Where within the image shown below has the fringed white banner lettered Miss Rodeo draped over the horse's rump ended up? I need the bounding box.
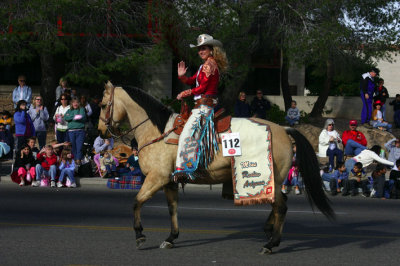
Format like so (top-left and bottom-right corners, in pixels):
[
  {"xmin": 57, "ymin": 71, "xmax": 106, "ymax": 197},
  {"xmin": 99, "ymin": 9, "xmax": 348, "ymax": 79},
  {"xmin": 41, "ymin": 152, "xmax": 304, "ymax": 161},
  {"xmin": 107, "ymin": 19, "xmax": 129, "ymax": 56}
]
[{"xmin": 231, "ymin": 118, "xmax": 275, "ymax": 205}]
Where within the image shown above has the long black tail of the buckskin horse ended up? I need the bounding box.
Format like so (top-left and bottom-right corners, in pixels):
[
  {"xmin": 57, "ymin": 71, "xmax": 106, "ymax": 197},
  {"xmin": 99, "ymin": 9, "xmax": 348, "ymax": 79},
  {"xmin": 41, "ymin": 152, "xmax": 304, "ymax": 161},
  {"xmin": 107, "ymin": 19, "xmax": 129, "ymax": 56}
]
[{"xmin": 286, "ymin": 128, "xmax": 335, "ymax": 221}]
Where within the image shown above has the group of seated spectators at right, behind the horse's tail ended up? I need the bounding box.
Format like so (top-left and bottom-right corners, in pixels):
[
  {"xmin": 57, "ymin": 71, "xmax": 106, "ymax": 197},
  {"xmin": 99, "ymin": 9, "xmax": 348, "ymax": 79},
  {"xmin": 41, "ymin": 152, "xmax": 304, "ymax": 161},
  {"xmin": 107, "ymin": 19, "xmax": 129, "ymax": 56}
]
[{"xmin": 319, "ymin": 119, "xmax": 400, "ymax": 199}]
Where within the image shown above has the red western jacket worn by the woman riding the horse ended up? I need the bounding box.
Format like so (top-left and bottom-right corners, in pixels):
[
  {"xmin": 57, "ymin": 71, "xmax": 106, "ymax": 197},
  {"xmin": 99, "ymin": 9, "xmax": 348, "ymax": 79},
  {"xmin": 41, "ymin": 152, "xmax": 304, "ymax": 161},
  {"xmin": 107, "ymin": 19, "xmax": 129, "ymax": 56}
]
[{"xmin": 179, "ymin": 57, "xmax": 219, "ymax": 95}]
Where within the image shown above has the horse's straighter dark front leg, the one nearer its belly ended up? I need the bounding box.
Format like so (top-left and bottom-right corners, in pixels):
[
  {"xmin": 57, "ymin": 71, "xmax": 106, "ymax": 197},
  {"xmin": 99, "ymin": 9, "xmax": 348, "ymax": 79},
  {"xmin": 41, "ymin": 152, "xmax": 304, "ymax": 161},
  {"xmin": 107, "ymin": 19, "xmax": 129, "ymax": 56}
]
[{"xmin": 160, "ymin": 182, "xmax": 179, "ymax": 248}]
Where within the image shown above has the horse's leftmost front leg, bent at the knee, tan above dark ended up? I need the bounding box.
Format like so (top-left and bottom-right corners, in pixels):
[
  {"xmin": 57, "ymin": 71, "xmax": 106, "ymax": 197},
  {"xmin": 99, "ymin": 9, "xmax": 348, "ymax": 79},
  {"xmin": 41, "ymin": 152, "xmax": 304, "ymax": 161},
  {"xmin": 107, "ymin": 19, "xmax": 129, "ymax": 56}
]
[{"xmin": 133, "ymin": 173, "xmax": 162, "ymax": 248}]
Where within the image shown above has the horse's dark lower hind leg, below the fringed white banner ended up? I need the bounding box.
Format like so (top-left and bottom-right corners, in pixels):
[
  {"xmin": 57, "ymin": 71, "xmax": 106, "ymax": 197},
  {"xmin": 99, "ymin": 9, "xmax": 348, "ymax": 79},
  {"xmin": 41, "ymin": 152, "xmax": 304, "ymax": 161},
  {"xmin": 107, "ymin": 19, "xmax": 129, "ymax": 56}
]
[{"xmin": 260, "ymin": 185, "xmax": 287, "ymax": 254}]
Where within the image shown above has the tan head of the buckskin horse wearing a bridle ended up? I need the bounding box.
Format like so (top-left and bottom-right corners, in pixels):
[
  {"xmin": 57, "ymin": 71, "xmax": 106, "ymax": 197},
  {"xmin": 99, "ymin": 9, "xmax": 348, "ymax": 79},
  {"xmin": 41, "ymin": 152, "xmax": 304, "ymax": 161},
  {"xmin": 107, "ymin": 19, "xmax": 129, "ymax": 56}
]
[{"xmin": 97, "ymin": 81, "xmax": 126, "ymax": 138}]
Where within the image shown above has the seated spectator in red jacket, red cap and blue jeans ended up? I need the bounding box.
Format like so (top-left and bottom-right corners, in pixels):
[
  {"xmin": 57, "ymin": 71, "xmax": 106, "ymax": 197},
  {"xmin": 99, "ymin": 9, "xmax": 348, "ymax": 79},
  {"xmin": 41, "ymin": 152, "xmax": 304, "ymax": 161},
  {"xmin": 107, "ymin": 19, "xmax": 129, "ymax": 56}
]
[{"xmin": 342, "ymin": 120, "xmax": 367, "ymax": 155}]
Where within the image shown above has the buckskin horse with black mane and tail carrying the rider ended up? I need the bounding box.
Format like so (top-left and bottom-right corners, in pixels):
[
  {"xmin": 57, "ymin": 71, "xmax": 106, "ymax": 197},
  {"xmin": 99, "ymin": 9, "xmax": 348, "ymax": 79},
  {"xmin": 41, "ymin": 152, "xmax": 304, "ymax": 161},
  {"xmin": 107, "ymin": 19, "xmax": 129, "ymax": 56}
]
[{"xmin": 98, "ymin": 82, "xmax": 335, "ymax": 254}]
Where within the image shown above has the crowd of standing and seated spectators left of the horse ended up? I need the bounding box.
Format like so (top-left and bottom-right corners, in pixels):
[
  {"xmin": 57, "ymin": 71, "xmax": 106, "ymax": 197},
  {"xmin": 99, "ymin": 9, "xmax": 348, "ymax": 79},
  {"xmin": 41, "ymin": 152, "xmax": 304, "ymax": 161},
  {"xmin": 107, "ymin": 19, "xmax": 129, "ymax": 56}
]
[{"xmin": 0, "ymin": 75, "xmax": 141, "ymax": 187}]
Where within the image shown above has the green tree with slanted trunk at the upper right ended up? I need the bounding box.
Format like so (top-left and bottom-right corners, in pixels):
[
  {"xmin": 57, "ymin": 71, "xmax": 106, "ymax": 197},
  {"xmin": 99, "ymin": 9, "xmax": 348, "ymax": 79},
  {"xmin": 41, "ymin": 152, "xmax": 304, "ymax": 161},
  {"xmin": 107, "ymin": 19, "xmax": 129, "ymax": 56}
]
[{"xmin": 272, "ymin": 0, "xmax": 400, "ymax": 116}]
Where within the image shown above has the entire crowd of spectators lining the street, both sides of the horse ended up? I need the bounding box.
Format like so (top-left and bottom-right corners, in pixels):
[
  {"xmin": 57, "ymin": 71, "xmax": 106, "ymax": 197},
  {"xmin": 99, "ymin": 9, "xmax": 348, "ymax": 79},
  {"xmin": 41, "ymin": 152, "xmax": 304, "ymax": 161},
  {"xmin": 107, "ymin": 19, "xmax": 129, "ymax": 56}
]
[{"xmin": 0, "ymin": 72, "xmax": 400, "ymax": 198}]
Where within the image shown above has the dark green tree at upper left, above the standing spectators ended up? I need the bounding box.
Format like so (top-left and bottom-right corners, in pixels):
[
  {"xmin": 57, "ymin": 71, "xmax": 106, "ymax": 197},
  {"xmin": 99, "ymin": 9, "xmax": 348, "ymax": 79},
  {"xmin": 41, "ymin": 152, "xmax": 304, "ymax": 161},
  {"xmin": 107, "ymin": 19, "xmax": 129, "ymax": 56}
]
[{"xmin": 0, "ymin": 0, "xmax": 160, "ymax": 105}]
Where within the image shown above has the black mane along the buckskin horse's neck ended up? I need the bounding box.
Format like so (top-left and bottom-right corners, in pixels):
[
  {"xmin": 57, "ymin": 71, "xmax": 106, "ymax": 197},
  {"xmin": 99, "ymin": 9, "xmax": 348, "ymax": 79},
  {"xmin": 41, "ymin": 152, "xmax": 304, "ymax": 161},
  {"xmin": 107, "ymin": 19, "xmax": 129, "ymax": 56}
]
[{"xmin": 121, "ymin": 86, "xmax": 173, "ymax": 133}]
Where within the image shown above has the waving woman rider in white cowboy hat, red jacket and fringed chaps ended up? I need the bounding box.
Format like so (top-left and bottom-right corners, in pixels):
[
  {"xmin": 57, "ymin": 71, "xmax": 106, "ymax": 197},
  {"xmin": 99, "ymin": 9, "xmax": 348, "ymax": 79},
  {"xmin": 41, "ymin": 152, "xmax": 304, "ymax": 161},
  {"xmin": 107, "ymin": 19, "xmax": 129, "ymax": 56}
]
[{"xmin": 173, "ymin": 34, "xmax": 228, "ymax": 181}]
